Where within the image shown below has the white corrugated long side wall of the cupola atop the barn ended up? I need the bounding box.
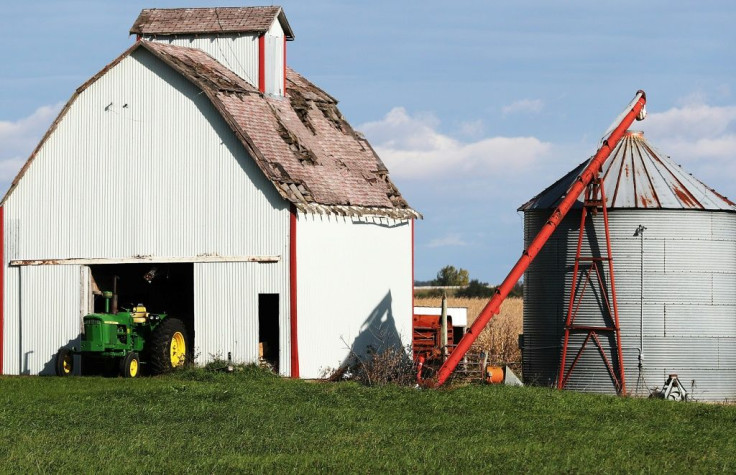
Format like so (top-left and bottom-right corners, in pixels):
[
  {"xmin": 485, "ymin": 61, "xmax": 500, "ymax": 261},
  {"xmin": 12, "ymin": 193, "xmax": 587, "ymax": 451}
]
[{"xmin": 151, "ymin": 34, "xmax": 260, "ymax": 88}]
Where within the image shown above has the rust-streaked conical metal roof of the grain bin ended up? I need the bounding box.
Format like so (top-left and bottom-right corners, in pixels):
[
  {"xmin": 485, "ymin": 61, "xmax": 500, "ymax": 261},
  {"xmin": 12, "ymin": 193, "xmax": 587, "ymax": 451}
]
[{"xmin": 519, "ymin": 131, "xmax": 736, "ymax": 211}]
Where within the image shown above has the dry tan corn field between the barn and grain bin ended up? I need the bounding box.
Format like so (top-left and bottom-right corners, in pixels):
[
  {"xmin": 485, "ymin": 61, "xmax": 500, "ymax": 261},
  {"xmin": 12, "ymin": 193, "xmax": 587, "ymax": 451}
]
[{"xmin": 414, "ymin": 297, "xmax": 523, "ymax": 369}]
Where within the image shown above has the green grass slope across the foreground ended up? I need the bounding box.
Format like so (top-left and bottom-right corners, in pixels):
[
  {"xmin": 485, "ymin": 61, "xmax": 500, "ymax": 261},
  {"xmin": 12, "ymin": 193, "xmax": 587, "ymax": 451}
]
[{"xmin": 0, "ymin": 369, "xmax": 736, "ymax": 473}]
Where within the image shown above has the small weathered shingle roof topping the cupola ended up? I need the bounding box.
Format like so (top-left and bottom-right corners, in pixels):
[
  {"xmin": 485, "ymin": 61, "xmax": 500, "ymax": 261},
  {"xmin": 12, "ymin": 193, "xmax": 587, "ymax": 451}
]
[{"xmin": 130, "ymin": 6, "xmax": 294, "ymax": 40}]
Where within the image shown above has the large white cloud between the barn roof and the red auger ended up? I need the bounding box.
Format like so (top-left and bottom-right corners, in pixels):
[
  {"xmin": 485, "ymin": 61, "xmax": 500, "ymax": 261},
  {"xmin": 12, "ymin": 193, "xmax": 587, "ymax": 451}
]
[{"xmin": 360, "ymin": 107, "xmax": 550, "ymax": 178}]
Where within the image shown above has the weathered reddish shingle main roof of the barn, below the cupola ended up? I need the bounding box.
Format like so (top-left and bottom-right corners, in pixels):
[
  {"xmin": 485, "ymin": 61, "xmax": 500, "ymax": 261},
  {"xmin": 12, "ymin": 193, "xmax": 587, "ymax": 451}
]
[{"xmin": 3, "ymin": 41, "xmax": 421, "ymax": 218}]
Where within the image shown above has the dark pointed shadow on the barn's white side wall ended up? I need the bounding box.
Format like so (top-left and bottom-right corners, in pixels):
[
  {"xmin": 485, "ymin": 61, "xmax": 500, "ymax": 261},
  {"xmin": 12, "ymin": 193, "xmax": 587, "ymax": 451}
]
[{"xmin": 340, "ymin": 290, "xmax": 406, "ymax": 368}]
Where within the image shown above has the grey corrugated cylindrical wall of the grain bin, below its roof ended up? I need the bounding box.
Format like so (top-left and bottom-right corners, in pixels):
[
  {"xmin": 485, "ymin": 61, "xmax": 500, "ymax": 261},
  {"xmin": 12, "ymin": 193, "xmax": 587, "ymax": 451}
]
[{"xmin": 524, "ymin": 209, "xmax": 736, "ymax": 400}]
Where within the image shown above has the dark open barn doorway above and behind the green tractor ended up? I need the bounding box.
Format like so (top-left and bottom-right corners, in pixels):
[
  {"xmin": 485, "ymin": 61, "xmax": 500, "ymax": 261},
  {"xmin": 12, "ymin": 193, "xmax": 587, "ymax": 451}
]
[{"xmin": 89, "ymin": 263, "xmax": 195, "ymax": 348}]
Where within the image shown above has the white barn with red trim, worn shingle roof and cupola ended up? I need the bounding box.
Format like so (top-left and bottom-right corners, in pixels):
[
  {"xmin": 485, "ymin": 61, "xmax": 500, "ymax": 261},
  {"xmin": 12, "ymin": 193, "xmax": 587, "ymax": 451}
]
[{"xmin": 0, "ymin": 7, "xmax": 420, "ymax": 378}]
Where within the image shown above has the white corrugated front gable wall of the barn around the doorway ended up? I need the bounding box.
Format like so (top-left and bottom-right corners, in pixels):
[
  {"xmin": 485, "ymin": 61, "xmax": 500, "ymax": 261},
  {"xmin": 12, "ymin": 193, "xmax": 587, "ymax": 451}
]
[{"xmin": 4, "ymin": 49, "xmax": 289, "ymax": 374}]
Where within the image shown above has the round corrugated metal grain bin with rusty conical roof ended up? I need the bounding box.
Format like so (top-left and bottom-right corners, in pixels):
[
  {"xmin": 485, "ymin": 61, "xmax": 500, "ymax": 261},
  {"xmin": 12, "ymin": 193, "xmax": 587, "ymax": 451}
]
[{"xmin": 520, "ymin": 131, "xmax": 736, "ymax": 400}]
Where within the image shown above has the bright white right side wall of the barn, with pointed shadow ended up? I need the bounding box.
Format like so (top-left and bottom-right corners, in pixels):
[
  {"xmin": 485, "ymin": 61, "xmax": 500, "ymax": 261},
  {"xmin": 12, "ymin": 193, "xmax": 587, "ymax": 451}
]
[{"xmin": 296, "ymin": 213, "xmax": 413, "ymax": 378}]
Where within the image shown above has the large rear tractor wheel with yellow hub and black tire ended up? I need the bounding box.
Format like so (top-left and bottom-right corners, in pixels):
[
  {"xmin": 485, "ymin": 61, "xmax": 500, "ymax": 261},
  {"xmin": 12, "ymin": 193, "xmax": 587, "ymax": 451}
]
[{"xmin": 149, "ymin": 318, "xmax": 189, "ymax": 374}]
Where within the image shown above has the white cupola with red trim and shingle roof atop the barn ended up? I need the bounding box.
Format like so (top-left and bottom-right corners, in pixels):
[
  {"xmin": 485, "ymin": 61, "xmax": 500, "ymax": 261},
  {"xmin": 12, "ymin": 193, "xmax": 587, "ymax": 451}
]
[{"xmin": 130, "ymin": 6, "xmax": 294, "ymax": 96}]
